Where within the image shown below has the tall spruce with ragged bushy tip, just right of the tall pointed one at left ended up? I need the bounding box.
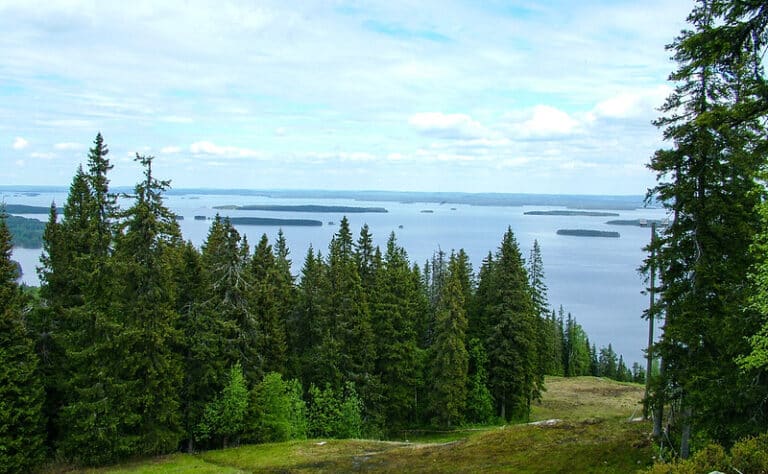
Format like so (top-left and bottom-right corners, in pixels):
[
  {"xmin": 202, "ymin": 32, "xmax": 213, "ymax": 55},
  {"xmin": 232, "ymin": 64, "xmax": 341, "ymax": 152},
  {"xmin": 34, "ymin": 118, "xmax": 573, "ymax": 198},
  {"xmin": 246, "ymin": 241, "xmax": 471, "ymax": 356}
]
[{"xmin": 112, "ymin": 154, "xmax": 182, "ymax": 455}]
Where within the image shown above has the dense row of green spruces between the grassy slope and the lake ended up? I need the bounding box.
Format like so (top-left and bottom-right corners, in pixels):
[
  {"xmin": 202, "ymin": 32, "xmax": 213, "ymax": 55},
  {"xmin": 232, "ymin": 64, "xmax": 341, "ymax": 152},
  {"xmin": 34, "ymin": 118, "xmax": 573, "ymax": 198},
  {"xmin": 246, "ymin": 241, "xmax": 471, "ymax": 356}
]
[{"xmin": 0, "ymin": 135, "xmax": 643, "ymax": 472}]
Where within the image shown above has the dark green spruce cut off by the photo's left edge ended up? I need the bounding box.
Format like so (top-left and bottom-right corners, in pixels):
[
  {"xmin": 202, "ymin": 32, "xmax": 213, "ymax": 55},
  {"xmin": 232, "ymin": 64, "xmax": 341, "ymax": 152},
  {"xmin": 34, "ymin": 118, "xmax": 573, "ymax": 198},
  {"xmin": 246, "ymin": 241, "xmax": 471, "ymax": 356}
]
[{"xmin": 0, "ymin": 206, "xmax": 45, "ymax": 472}]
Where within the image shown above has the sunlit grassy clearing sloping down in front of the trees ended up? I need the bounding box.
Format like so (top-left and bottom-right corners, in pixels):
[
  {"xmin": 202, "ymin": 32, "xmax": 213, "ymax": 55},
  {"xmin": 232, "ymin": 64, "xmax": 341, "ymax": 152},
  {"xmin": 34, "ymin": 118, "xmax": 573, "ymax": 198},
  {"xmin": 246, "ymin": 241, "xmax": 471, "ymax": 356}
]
[{"xmin": 66, "ymin": 377, "xmax": 652, "ymax": 474}]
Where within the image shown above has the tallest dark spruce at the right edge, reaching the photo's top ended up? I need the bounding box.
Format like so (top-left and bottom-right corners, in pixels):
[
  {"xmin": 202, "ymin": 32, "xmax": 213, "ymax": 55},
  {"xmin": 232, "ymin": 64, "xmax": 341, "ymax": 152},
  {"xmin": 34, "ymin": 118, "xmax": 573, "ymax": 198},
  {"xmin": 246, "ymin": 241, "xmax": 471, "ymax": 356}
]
[{"xmin": 649, "ymin": 0, "xmax": 766, "ymax": 450}]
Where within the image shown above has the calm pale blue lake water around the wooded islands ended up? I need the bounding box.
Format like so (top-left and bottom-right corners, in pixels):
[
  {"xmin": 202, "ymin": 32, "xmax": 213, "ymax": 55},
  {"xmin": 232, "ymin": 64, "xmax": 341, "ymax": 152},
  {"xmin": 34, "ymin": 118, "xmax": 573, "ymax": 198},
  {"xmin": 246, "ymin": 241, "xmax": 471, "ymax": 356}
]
[{"xmin": 4, "ymin": 193, "xmax": 664, "ymax": 366}]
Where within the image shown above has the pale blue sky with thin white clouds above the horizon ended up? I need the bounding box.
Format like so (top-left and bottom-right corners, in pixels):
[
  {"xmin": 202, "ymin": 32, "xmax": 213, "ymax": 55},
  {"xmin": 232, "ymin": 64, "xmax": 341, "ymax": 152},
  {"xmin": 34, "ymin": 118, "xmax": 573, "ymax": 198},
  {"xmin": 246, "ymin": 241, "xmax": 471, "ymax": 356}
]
[{"xmin": 0, "ymin": 0, "xmax": 693, "ymax": 194}]
